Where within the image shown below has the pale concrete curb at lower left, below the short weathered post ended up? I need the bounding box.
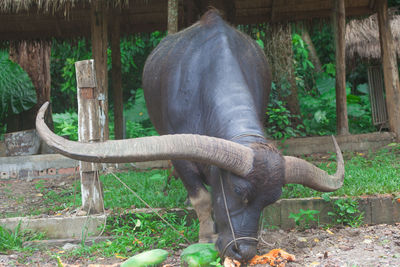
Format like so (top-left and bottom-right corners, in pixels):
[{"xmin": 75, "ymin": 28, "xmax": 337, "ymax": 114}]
[{"xmin": 0, "ymin": 215, "xmax": 106, "ymax": 239}]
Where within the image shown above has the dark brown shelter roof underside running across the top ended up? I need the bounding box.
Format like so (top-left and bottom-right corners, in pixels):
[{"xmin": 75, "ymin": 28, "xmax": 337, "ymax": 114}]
[{"xmin": 0, "ymin": 0, "xmax": 380, "ymax": 41}]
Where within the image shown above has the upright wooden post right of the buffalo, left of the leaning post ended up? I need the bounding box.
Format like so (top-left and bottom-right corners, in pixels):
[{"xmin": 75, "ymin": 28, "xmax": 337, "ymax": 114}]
[{"xmin": 333, "ymin": 0, "xmax": 349, "ymax": 135}]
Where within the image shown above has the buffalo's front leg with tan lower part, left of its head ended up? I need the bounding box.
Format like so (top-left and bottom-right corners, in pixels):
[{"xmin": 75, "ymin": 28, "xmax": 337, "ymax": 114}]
[{"xmin": 172, "ymin": 160, "xmax": 217, "ymax": 243}]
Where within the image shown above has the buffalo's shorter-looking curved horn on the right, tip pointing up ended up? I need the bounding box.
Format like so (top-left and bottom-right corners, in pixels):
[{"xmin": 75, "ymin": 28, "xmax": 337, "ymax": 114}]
[{"xmin": 284, "ymin": 136, "xmax": 344, "ymax": 192}]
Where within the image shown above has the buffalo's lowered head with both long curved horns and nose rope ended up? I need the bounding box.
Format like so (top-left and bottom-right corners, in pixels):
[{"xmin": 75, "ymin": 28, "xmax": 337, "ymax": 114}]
[{"xmin": 36, "ymin": 103, "xmax": 344, "ymax": 261}]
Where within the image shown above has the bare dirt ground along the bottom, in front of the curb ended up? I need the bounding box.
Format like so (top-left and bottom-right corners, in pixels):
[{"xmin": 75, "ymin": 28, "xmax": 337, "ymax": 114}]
[{"xmin": 0, "ymin": 224, "xmax": 400, "ymax": 267}]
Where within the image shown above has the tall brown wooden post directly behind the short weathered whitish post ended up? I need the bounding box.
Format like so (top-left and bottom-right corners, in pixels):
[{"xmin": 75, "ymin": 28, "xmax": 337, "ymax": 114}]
[{"xmin": 91, "ymin": 0, "xmax": 109, "ymax": 141}]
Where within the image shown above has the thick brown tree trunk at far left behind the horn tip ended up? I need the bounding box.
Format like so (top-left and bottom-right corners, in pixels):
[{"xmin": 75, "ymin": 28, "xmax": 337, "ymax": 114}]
[{"xmin": 7, "ymin": 41, "xmax": 53, "ymax": 132}]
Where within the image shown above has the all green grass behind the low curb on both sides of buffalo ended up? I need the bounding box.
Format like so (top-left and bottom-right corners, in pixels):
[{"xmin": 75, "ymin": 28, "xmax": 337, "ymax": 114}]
[{"xmin": 36, "ymin": 145, "xmax": 400, "ymax": 213}]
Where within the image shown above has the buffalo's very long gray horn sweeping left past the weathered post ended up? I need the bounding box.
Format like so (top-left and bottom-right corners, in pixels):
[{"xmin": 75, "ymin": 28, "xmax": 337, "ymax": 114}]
[{"xmin": 36, "ymin": 102, "xmax": 254, "ymax": 177}]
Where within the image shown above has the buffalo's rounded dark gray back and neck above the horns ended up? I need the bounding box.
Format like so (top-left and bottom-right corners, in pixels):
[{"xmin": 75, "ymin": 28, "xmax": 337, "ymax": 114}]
[{"xmin": 143, "ymin": 12, "xmax": 270, "ymax": 142}]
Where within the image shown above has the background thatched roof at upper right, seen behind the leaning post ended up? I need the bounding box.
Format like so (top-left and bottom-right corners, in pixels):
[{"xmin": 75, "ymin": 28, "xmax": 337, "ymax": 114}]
[{"xmin": 346, "ymin": 9, "xmax": 400, "ymax": 59}]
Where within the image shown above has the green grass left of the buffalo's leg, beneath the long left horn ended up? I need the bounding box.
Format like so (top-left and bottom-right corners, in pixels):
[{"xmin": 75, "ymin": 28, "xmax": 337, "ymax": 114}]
[{"xmin": 42, "ymin": 170, "xmax": 187, "ymax": 214}]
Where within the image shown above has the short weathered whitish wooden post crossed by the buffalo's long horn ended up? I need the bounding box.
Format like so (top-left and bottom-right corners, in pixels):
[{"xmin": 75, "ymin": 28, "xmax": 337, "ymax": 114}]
[{"xmin": 75, "ymin": 60, "xmax": 104, "ymax": 214}]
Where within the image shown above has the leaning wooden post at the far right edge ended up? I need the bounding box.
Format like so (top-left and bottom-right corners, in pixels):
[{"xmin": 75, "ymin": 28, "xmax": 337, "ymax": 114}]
[{"xmin": 376, "ymin": 0, "xmax": 400, "ymax": 141}]
